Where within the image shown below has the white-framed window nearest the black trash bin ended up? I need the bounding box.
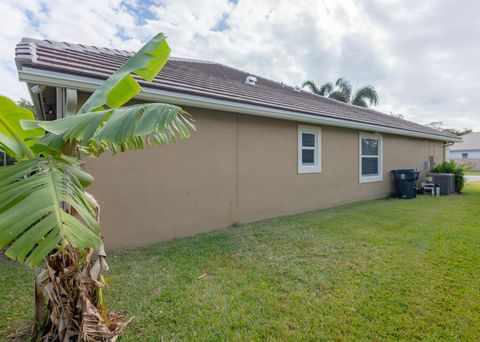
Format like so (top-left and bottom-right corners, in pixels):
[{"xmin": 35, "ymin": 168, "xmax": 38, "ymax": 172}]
[{"xmin": 359, "ymin": 133, "xmax": 383, "ymax": 183}]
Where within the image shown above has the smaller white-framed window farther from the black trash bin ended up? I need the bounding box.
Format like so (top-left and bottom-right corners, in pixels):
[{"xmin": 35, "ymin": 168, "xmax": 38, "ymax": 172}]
[{"xmin": 298, "ymin": 126, "xmax": 322, "ymax": 173}]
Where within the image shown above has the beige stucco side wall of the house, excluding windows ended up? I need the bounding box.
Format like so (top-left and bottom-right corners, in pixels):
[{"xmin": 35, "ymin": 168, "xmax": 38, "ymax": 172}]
[{"xmin": 83, "ymin": 104, "xmax": 443, "ymax": 249}]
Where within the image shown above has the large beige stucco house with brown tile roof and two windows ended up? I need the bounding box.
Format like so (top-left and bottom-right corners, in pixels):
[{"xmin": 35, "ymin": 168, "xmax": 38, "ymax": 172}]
[{"xmin": 16, "ymin": 39, "xmax": 459, "ymax": 248}]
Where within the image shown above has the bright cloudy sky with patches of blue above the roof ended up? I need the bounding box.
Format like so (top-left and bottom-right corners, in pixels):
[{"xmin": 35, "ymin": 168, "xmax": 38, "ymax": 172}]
[{"xmin": 0, "ymin": 0, "xmax": 480, "ymax": 131}]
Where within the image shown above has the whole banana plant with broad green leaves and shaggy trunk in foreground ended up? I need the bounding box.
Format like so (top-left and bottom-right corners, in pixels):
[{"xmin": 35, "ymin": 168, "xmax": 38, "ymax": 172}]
[{"xmin": 0, "ymin": 33, "xmax": 194, "ymax": 341}]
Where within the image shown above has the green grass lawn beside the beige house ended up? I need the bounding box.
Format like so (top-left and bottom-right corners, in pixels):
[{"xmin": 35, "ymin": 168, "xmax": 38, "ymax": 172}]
[{"xmin": 0, "ymin": 184, "xmax": 480, "ymax": 341}]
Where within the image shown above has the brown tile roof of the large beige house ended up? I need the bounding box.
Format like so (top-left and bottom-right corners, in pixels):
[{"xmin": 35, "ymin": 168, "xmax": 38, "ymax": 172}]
[{"xmin": 15, "ymin": 38, "xmax": 455, "ymax": 139}]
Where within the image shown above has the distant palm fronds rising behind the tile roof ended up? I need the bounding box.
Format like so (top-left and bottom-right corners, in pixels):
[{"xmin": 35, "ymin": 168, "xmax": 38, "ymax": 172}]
[{"xmin": 303, "ymin": 77, "xmax": 378, "ymax": 108}]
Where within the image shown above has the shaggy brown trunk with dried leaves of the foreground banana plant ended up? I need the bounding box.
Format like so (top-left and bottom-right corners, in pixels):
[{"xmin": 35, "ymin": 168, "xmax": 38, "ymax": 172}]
[{"xmin": 33, "ymin": 188, "xmax": 130, "ymax": 342}]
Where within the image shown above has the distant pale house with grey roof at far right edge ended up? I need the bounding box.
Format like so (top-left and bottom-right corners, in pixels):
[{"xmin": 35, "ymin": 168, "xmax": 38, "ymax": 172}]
[{"xmin": 448, "ymin": 132, "xmax": 480, "ymax": 171}]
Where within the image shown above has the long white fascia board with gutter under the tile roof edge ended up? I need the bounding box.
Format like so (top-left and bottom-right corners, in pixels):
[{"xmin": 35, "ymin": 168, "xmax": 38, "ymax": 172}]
[{"xmin": 18, "ymin": 67, "xmax": 461, "ymax": 142}]
